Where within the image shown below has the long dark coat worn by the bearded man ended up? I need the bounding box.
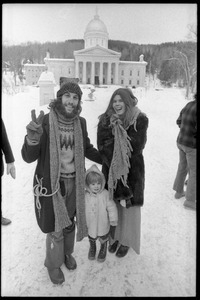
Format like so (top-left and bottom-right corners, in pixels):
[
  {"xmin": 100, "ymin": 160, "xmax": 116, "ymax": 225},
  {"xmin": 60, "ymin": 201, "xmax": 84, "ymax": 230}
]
[{"xmin": 21, "ymin": 114, "xmax": 102, "ymax": 233}]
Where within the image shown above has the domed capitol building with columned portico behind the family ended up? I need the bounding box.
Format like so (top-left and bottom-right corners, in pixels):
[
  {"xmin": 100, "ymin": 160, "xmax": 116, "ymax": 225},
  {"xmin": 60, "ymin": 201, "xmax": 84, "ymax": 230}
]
[{"xmin": 24, "ymin": 12, "xmax": 147, "ymax": 87}]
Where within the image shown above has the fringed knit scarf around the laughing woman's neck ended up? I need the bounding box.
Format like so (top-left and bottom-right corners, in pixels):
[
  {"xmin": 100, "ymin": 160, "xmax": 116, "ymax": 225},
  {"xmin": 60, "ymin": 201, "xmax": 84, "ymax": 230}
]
[{"xmin": 108, "ymin": 107, "xmax": 140, "ymax": 199}]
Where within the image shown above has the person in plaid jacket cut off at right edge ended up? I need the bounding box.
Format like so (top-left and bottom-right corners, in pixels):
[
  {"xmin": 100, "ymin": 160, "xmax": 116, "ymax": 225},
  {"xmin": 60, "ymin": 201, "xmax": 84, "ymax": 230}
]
[{"xmin": 173, "ymin": 94, "xmax": 197, "ymax": 210}]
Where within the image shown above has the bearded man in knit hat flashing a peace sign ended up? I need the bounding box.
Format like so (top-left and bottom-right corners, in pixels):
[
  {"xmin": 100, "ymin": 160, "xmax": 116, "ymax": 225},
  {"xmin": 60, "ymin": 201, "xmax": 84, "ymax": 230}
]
[{"xmin": 22, "ymin": 82, "xmax": 102, "ymax": 284}]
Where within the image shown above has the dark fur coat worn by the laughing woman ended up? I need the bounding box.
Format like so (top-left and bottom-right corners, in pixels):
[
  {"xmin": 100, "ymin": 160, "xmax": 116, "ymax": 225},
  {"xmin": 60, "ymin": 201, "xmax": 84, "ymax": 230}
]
[{"xmin": 97, "ymin": 112, "xmax": 149, "ymax": 206}]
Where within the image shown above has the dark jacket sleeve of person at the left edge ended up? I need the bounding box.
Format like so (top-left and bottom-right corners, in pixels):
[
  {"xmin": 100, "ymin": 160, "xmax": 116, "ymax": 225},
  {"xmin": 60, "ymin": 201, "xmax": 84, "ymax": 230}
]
[{"xmin": 1, "ymin": 119, "xmax": 15, "ymax": 176}]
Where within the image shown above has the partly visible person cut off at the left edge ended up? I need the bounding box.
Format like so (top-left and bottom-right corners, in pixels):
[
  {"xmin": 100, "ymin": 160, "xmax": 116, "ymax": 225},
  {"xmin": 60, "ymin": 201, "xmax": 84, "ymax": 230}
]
[{"xmin": 1, "ymin": 119, "xmax": 16, "ymax": 225}]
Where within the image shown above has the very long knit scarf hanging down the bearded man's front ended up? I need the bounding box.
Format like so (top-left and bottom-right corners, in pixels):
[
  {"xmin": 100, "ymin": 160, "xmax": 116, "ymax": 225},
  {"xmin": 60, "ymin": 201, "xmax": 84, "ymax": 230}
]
[{"xmin": 49, "ymin": 109, "xmax": 87, "ymax": 241}]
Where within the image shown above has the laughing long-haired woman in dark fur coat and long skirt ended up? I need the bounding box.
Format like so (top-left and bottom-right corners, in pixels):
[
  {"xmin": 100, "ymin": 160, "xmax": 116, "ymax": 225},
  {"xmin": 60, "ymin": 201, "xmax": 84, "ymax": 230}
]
[{"xmin": 97, "ymin": 88, "xmax": 148, "ymax": 257}]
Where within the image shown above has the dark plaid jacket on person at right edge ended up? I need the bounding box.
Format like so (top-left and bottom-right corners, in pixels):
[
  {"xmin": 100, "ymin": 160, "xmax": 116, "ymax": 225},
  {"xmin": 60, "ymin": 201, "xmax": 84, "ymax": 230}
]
[{"xmin": 176, "ymin": 100, "xmax": 197, "ymax": 148}]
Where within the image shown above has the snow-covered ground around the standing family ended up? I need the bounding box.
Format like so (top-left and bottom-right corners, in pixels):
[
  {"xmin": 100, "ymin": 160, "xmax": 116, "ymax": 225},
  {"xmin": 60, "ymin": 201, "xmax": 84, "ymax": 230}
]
[{"xmin": 1, "ymin": 85, "xmax": 196, "ymax": 297}]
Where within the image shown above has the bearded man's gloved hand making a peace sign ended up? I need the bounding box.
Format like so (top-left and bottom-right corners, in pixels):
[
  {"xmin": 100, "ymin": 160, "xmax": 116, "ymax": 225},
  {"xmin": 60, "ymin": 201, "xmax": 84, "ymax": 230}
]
[{"xmin": 26, "ymin": 109, "xmax": 44, "ymax": 143}]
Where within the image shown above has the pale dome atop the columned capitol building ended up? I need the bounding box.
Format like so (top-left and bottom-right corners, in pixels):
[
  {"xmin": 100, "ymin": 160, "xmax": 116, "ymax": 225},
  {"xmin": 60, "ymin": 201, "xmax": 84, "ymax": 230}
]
[{"xmin": 84, "ymin": 13, "xmax": 108, "ymax": 48}]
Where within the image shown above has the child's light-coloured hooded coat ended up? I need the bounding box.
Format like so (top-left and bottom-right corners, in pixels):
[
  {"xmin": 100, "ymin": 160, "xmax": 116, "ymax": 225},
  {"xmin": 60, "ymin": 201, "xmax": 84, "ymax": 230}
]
[{"xmin": 85, "ymin": 165, "xmax": 118, "ymax": 238}]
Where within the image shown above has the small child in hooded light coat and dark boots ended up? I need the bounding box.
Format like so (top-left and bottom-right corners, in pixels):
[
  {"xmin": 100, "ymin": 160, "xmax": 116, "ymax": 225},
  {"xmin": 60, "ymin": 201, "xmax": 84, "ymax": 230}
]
[{"xmin": 85, "ymin": 165, "xmax": 118, "ymax": 262}]
